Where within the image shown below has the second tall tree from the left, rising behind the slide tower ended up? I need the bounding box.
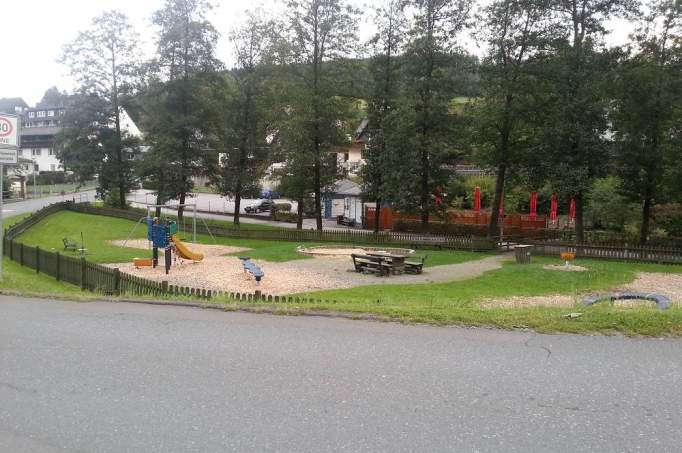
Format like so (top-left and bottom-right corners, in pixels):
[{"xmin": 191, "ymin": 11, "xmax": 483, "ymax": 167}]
[{"xmin": 141, "ymin": 0, "xmax": 220, "ymax": 219}]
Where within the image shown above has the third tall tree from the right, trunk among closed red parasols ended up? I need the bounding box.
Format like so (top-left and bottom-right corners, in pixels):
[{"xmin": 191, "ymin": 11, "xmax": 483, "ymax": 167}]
[{"xmin": 474, "ymin": 0, "xmax": 555, "ymax": 237}]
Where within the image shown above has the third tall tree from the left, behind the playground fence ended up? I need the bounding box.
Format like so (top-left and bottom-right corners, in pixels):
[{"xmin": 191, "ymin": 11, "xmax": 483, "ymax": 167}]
[{"xmin": 211, "ymin": 13, "xmax": 274, "ymax": 225}]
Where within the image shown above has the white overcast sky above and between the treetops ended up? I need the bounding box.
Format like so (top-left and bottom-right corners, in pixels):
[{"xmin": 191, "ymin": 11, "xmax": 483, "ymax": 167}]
[{"xmin": 0, "ymin": 0, "xmax": 631, "ymax": 105}]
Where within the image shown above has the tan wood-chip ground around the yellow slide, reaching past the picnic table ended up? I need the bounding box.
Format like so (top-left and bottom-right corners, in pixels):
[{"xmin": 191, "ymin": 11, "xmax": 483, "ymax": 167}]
[{"xmin": 103, "ymin": 240, "xmax": 504, "ymax": 295}]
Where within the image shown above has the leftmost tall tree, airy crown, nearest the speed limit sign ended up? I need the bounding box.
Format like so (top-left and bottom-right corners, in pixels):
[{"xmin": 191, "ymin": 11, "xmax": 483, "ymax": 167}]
[{"xmin": 61, "ymin": 11, "xmax": 138, "ymax": 208}]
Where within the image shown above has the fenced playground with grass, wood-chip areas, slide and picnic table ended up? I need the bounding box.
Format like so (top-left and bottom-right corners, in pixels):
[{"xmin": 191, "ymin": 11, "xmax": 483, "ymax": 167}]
[{"xmin": 6, "ymin": 206, "xmax": 682, "ymax": 334}]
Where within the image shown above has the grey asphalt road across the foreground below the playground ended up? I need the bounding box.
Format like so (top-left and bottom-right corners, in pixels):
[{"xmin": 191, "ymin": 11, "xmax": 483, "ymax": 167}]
[{"xmin": 0, "ymin": 297, "xmax": 682, "ymax": 452}]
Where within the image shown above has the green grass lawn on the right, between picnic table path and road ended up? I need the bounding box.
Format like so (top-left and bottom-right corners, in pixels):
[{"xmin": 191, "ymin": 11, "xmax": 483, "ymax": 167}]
[{"xmin": 290, "ymin": 257, "xmax": 682, "ymax": 335}]
